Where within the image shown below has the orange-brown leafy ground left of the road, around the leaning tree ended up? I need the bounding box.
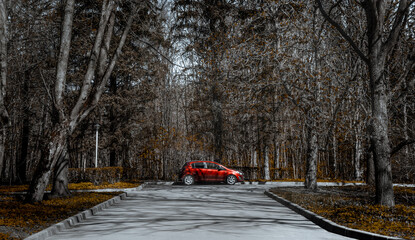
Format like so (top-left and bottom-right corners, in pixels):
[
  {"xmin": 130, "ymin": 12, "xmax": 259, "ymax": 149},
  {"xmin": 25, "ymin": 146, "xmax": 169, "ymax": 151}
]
[{"xmin": 0, "ymin": 182, "xmax": 140, "ymax": 239}]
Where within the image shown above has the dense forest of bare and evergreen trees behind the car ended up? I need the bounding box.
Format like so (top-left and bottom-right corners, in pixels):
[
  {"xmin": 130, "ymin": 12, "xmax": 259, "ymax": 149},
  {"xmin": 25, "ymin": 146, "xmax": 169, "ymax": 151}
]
[{"xmin": 0, "ymin": 0, "xmax": 415, "ymax": 206}]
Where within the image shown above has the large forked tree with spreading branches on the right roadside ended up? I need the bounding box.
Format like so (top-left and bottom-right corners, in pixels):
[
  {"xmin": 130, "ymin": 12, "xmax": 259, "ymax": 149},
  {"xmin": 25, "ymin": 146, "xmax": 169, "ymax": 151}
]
[{"xmin": 316, "ymin": 0, "xmax": 414, "ymax": 206}]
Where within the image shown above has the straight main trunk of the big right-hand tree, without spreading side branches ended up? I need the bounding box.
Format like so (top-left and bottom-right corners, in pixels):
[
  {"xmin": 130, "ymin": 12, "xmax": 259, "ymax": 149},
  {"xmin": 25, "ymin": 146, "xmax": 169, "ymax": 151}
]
[{"xmin": 365, "ymin": 1, "xmax": 396, "ymax": 207}]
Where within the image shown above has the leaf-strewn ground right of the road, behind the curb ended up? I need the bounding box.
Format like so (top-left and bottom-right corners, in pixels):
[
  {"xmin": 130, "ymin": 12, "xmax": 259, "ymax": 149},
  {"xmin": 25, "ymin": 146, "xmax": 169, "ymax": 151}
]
[{"xmin": 270, "ymin": 186, "xmax": 415, "ymax": 239}]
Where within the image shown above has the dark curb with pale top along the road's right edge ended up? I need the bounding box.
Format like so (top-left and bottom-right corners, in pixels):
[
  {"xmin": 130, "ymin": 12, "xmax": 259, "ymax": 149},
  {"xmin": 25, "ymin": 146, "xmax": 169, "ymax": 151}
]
[{"xmin": 264, "ymin": 191, "xmax": 402, "ymax": 240}]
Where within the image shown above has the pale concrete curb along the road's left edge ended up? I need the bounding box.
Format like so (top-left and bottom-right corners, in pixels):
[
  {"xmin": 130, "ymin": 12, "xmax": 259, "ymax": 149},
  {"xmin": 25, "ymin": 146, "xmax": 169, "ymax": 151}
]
[{"xmin": 25, "ymin": 183, "xmax": 147, "ymax": 240}]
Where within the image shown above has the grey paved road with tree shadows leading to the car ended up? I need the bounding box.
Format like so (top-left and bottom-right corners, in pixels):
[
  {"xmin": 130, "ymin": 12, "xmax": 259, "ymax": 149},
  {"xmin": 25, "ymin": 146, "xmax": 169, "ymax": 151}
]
[{"xmin": 48, "ymin": 184, "xmax": 349, "ymax": 240}]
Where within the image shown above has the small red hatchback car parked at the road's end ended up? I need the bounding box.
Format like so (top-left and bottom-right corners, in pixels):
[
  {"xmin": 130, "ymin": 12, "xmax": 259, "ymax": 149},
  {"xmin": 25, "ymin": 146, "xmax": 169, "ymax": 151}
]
[{"xmin": 179, "ymin": 161, "xmax": 244, "ymax": 185}]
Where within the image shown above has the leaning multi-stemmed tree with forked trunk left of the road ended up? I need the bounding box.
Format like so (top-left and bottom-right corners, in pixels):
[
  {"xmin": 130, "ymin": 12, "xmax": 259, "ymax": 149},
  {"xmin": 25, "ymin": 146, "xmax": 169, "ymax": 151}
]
[{"xmin": 26, "ymin": 0, "xmax": 136, "ymax": 202}]
